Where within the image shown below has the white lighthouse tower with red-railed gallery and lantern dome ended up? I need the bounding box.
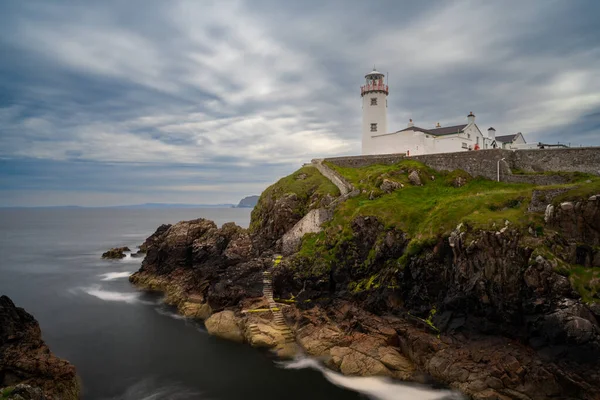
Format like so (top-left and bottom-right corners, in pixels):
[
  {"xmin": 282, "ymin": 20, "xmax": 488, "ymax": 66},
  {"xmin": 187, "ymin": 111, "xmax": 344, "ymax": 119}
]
[{"xmin": 360, "ymin": 68, "xmax": 389, "ymax": 154}]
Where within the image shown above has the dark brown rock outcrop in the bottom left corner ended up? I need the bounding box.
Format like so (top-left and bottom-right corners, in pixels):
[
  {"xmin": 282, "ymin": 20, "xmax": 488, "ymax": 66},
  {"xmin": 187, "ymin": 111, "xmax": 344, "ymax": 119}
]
[{"xmin": 0, "ymin": 296, "xmax": 79, "ymax": 400}]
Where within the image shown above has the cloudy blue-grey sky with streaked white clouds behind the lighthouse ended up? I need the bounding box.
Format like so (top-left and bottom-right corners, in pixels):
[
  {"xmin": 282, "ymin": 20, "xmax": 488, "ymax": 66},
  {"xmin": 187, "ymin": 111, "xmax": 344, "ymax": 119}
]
[{"xmin": 0, "ymin": 0, "xmax": 600, "ymax": 206}]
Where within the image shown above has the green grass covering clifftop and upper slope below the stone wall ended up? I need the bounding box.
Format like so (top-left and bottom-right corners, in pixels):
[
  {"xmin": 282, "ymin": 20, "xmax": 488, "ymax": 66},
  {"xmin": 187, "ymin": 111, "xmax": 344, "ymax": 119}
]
[{"xmin": 276, "ymin": 160, "xmax": 600, "ymax": 300}]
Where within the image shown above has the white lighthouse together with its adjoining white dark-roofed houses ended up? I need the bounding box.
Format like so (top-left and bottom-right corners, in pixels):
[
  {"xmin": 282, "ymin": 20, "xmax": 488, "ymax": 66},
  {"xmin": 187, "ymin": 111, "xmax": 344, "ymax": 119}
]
[{"xmin": 361, "ymin": 70, "xmax": 525, "ymax": 155}]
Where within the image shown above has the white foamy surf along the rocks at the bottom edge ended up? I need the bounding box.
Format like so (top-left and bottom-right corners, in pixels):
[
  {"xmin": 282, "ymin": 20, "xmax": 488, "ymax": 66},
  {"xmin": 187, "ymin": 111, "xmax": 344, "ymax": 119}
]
[{"xmin": 277, "ymin": 357, "xmax": 464, "ymax": 400}]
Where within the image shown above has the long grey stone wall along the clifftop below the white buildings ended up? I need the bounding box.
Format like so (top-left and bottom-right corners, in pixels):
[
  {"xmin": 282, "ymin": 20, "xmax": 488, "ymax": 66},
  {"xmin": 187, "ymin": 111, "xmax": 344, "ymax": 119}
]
[{"xmin": 324, "ymin": 147, "xmax": 600, "ymax": 183}]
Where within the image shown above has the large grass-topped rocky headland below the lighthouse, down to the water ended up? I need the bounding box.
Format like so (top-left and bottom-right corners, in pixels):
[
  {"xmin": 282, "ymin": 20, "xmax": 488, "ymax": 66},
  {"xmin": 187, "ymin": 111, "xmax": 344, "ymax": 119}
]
[{"xmin": 131, "ymin": 161, "xmax": 600, "ymax": 399}]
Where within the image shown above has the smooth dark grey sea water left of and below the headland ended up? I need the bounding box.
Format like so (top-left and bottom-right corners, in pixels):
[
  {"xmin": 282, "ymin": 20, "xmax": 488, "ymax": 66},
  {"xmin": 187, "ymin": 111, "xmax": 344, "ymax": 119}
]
[{"xmin": 0, "ymin": 208, "xmax": 455, "ymax": 400}]
